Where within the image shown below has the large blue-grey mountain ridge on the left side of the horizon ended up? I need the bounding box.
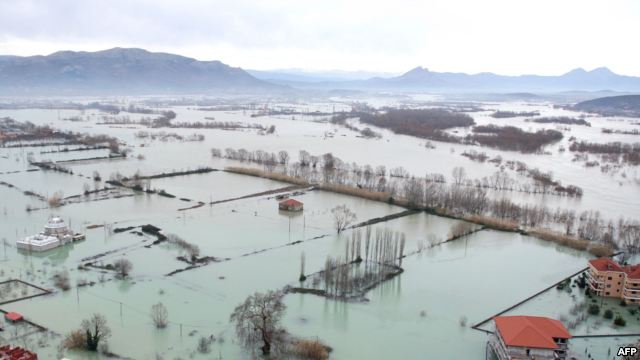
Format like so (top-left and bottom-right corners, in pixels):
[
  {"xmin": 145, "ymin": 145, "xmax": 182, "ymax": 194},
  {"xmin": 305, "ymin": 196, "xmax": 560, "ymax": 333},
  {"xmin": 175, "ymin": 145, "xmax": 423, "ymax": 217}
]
[{"xmin": 0, "ymin": 48, "xmax": 281, "ymax": 95}]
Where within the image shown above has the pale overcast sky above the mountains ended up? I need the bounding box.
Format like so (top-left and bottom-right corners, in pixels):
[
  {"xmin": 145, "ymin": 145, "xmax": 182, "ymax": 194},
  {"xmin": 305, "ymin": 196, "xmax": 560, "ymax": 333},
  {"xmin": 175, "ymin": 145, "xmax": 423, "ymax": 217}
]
[{"xmin": 0, "ymin": 0, "xmax": 640, "ymax": 76}]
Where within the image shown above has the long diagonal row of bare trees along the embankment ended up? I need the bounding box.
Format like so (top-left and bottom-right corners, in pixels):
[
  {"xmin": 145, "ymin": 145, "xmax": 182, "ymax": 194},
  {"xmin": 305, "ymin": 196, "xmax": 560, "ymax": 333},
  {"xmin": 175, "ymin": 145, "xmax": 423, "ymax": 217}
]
[{"xmin": 219, "ymin": 146, "xmax": 640, "ymax": 251}]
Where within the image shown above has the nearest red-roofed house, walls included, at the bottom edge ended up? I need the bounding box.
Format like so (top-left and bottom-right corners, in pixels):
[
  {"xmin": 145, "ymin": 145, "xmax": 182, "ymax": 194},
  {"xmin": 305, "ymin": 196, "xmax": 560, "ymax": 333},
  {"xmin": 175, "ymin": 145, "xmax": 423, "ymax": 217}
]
[{"xmin": 489, "ymin": 316, "xmax": 571, "ymax": 360}]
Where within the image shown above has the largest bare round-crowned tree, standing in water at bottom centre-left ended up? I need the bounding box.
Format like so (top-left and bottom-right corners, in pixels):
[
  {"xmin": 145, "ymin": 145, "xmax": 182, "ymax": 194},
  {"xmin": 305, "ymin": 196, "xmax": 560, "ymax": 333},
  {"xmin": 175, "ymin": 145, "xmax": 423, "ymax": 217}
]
[{"xmin": 230, "ymin": 291, "xmax": 286, "ymax": 355}]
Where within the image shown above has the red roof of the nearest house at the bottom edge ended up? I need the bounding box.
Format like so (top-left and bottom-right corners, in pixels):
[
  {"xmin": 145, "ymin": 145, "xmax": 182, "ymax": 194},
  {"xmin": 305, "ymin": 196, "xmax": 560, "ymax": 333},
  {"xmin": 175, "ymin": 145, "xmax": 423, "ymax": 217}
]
[{"xmin": 493, "ymin": 316, "xmax": 571, "ymax": 349}]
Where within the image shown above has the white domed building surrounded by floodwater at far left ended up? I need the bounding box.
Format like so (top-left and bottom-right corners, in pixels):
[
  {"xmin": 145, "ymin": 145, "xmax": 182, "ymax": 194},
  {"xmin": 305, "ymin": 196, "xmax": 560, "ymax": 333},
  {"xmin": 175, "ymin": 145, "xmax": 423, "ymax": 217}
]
[{"xmin": 16, "ymin": 217, "xmax": 84, "ymax": 252}]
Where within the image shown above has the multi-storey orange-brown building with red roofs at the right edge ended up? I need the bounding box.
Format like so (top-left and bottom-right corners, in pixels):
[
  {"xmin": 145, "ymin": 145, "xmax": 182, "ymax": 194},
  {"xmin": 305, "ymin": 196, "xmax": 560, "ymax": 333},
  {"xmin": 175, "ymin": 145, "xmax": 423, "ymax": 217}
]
[{"xmin": 587, "ymin": 258, "xmax": 640, "ymax": 304}]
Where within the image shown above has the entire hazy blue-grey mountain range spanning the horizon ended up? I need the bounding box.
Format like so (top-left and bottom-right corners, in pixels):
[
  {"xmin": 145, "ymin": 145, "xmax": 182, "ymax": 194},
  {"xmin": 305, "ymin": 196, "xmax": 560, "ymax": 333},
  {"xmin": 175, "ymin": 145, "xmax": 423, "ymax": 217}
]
[{"xmin": 0, "ymin": 48, "xmax": 640, "ymax": 95}]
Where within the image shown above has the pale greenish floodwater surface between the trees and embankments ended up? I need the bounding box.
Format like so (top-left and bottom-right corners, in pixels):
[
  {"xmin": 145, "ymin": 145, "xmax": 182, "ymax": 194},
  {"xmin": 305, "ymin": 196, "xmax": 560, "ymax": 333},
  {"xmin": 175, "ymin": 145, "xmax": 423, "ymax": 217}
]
[{"xmin": 0, "ymin": 96, "xmax": 640, "ymax": 360}]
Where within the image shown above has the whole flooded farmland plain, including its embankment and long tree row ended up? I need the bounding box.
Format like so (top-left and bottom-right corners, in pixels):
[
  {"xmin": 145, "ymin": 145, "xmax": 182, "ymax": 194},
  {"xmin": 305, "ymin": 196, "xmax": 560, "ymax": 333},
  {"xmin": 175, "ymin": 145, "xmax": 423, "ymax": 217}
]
[{"xmin": 0, "ymin": 97, "xmax": 640, "ymax": 360}]
